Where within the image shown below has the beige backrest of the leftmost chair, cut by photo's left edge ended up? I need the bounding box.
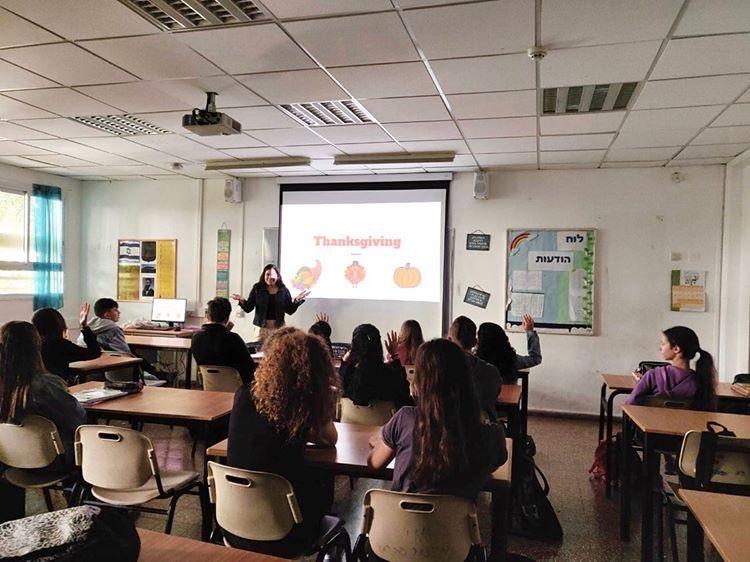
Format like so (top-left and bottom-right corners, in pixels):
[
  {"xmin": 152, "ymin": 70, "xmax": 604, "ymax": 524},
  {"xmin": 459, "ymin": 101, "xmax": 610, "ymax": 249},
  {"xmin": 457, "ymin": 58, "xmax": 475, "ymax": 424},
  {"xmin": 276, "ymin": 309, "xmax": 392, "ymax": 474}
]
[{"xmin": 0, "ymin": 415, "xmax": 65, "ymax": 469}]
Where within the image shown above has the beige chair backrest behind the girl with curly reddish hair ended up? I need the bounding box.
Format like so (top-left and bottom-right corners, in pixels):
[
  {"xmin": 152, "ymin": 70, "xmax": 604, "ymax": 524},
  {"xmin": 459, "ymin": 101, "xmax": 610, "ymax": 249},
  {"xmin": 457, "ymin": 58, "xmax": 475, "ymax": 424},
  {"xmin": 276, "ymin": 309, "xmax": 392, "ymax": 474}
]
[{"xmin": 208, "ymin": 461, "xmax": 302, "ymax": 541}]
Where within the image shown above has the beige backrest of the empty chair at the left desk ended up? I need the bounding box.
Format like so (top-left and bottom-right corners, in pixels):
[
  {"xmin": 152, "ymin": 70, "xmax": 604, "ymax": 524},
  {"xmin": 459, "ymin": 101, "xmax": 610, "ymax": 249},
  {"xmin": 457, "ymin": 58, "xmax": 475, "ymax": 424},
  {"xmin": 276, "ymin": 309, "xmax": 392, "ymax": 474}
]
[{"xmin": 75, "ymin": 425, "xmax": 161, "ymax": 491}]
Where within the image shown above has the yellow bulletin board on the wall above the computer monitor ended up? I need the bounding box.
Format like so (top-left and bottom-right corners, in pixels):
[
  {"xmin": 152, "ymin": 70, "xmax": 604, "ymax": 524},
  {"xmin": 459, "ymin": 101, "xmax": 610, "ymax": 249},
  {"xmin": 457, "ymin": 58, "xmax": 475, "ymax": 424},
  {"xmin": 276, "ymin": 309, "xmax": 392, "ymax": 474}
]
[{"xmin": 117, "ymin": 239, "xmax": 177, "ymax": 301}]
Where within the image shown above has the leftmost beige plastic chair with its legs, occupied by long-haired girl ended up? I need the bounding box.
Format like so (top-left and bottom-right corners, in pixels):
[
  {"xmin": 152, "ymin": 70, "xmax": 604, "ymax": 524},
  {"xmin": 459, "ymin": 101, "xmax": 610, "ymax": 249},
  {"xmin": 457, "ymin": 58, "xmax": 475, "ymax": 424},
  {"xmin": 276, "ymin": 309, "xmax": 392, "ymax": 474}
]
[{"xmin": 0, "ymin": 415, "xmax": 78, "ymax": 511}]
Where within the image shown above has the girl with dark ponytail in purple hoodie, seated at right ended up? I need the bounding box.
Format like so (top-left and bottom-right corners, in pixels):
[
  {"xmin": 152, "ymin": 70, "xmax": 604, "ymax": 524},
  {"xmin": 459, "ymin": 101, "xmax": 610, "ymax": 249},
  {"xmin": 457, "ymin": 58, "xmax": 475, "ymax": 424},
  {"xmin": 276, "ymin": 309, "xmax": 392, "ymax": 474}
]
[{"xmin": 625, "ymin": 326, "xmax": 716, "ymax": 411}]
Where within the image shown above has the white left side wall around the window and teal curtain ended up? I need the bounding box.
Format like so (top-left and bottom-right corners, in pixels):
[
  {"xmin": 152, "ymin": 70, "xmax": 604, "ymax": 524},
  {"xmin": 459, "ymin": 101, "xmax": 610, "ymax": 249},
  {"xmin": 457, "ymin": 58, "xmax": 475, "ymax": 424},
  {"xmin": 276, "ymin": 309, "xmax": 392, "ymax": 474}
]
[{"xmin": 0, "ymin": 164, "xmax": 81, "ymax": 327}]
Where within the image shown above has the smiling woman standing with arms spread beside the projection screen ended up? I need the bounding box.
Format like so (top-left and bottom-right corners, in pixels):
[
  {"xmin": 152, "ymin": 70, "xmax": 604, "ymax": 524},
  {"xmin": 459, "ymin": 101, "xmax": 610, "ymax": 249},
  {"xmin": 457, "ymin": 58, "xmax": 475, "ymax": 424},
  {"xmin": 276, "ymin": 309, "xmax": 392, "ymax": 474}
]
[{"xmin": 232, "ymin": 263, "xmax": 310, "ymax": 341}]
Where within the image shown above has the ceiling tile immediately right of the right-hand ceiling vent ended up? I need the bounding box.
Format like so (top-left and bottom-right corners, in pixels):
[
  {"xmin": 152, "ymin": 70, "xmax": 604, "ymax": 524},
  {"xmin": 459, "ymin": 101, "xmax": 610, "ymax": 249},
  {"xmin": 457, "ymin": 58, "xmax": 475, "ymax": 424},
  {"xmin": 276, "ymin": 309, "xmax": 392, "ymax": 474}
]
[{"xmin": 633, "ymin": 74, "xmax": 750, "ymax": 109}]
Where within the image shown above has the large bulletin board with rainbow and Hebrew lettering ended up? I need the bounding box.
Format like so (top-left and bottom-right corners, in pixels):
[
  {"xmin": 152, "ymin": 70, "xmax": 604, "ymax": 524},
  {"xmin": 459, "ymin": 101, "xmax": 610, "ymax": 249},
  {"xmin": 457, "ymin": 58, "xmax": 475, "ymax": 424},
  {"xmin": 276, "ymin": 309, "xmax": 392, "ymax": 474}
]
[{"xmin": 505, "ymin": 229, "xmax": 596, "ymax": 335}]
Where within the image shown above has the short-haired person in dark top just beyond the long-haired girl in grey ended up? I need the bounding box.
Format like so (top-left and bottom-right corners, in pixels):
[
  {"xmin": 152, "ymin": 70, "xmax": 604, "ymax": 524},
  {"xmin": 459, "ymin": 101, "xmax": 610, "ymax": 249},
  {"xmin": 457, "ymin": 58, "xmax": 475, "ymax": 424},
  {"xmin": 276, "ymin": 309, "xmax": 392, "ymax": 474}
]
[{"xmin": 448, "ymin": 316, "xmax": 503, "ymax": 421}]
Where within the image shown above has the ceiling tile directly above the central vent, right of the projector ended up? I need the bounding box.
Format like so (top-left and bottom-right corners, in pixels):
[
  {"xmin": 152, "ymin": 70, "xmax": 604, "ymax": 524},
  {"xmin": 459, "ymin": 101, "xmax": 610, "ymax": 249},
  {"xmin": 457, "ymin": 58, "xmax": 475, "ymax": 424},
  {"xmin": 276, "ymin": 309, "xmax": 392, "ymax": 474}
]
[{"xmin": 237, "ymin": 69, "xmax": 348, "ymax": 104}]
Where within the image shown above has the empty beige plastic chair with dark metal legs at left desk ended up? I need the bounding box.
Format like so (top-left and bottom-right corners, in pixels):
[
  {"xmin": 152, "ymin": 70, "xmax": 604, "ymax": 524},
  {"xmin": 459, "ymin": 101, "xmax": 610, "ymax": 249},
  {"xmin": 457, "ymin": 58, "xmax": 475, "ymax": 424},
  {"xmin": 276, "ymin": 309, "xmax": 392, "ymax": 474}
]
[{"xmin": 75, "ymin": 425, "xmax": 208, "ymax": 537}]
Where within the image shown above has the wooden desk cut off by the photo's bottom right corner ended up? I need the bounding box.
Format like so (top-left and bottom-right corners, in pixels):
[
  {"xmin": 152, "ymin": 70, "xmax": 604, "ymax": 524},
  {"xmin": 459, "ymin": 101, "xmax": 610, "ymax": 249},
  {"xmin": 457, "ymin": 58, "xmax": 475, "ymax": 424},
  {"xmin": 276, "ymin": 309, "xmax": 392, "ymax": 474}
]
[{"xmin": 678, "ymin": 489, "xmax": 750, "ymax": 562}]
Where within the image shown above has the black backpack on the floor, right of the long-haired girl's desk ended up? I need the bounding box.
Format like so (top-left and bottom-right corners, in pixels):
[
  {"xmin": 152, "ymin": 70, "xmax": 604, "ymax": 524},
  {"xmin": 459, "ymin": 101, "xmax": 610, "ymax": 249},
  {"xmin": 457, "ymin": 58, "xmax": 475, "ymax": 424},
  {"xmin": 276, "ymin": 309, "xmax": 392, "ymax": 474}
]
[{"xmin": 511, "ymin": 436, "xmax": 563, "ymax": 541}]
